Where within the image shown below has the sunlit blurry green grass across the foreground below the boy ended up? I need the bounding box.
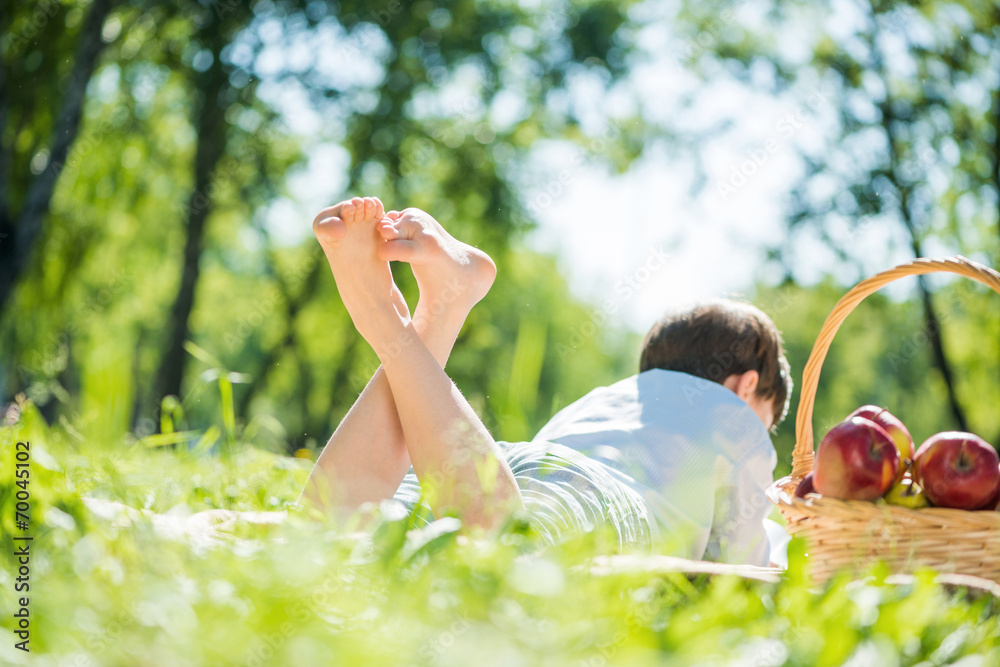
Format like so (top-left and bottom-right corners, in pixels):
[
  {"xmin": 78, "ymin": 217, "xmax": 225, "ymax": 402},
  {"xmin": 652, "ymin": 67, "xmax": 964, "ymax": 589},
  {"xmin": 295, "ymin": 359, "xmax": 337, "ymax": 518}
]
[{"xmin": 0, "ymin": 404, "xmax": 1000, "ymax": 667}]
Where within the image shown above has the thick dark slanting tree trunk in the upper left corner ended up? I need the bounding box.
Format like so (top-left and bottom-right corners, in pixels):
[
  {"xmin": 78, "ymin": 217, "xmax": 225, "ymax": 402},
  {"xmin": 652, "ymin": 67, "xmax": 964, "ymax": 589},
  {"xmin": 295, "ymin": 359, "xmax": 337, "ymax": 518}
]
[{"xmin": 0, "ymin": 0, "xmax": 115, "ymax": 312}]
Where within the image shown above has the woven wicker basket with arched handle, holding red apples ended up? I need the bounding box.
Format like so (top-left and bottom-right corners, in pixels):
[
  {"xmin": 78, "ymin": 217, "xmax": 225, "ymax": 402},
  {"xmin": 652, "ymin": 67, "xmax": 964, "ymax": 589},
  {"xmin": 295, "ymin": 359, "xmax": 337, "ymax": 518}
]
[{"xmin": 768, "ymin": 257, "xmax": 1000, "ymax": 582}]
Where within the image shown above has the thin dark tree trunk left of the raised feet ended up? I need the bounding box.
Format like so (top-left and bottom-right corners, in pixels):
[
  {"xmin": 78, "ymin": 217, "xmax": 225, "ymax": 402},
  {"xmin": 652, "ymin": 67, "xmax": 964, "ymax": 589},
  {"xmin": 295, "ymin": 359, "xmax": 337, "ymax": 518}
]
[{"xmin": 153, "ymin": 32, "xmax": 229, "ymax": 410}]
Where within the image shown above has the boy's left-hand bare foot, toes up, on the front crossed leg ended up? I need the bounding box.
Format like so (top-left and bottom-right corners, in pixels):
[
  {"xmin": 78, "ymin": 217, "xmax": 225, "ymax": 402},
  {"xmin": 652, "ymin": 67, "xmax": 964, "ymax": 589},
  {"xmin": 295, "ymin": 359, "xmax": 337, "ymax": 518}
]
[{"xmin": 313, "ymin": 197, "xmax": 410, "ymax": 344}]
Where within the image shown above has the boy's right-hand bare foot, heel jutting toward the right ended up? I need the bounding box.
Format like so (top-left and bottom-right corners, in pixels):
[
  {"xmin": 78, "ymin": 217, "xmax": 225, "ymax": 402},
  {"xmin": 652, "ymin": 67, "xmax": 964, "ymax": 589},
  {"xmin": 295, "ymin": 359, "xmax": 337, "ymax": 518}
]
[{"xmin": 378, "ymin": 208, "xmax": 497, "ymax": 321}]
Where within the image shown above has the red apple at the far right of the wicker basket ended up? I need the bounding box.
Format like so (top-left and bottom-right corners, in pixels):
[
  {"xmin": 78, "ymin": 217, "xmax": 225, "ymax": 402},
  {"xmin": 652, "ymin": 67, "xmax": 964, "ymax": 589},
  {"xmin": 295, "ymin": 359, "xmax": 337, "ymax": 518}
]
[{"xmin": 913, "ymin": 431, "xmax": 1000, "ymax": 510}]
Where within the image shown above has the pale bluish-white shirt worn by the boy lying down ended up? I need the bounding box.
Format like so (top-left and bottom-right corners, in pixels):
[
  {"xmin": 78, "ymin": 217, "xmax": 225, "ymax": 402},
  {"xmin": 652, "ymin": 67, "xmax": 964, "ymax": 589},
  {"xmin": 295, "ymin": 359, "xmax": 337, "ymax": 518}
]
[{"xmin": 534, "ymin": 369, "xmax": 777, "ymax": 566}]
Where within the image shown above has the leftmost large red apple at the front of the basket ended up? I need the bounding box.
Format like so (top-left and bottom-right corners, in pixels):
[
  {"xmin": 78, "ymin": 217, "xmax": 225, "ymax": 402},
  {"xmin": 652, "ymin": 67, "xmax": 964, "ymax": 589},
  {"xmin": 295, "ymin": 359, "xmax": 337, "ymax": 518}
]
[{"xmin": 813, "ymin": 417, "xmax": 900, "ymax": 500}]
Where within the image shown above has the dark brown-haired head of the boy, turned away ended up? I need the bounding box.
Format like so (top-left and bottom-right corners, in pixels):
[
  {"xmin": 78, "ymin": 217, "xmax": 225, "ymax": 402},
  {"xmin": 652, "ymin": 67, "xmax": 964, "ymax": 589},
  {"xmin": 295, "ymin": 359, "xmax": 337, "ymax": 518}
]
[{"xmin": 639, "ymin": 300, "xmax": 792, "ymax": 428}]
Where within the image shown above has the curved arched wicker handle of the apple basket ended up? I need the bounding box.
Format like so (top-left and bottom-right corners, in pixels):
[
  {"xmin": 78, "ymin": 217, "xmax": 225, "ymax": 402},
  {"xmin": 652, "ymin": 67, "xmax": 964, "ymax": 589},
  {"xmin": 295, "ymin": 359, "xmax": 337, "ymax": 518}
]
[{"xmin": 792, "ymin": 255, "xmax": 1000, "ymax": 478}]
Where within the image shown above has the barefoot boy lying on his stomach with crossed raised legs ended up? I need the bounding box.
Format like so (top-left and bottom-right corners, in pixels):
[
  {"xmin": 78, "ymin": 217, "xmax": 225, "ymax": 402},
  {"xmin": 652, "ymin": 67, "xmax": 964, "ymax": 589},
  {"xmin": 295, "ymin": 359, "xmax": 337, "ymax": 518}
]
[{"xmin": 304, "ymin": 197, "xmax": 789, "ymax": 565}]
